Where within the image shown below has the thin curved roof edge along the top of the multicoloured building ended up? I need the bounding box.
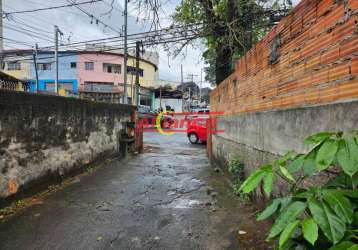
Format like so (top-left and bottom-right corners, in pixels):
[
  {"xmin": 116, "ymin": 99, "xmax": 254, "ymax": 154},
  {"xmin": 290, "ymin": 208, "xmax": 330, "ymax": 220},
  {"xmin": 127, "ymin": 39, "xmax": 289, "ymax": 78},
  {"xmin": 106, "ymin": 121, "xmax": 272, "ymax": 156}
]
[{"xmin": 3, "ymin": 49, "xmax": 158, "ymax": 71}]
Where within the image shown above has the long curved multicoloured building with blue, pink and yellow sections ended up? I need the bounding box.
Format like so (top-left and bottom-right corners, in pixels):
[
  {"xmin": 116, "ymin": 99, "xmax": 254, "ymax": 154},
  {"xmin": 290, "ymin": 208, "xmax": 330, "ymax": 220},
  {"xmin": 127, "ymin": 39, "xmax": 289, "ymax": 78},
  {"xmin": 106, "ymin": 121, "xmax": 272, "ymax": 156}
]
[{"xmin": 3, "ymin": 50, "xmax": 158, "ymax": 103}]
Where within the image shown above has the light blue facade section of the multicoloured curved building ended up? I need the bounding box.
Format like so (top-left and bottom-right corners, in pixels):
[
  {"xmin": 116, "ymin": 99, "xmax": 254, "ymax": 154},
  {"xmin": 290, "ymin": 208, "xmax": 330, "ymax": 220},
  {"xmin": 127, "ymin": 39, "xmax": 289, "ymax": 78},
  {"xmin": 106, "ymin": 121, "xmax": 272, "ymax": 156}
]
[{"xmin": 30, "ymin": 52, "xmax": 78, "ymax": 95}]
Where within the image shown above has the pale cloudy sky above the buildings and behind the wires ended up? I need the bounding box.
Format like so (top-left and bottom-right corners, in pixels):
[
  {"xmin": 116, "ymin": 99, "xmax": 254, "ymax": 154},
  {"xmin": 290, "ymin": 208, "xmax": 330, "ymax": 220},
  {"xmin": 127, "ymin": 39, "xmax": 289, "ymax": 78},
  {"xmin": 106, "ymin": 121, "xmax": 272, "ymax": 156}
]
[{"xmin": 3, "ymin": 0, "xmax": 298, "ymax": 85}]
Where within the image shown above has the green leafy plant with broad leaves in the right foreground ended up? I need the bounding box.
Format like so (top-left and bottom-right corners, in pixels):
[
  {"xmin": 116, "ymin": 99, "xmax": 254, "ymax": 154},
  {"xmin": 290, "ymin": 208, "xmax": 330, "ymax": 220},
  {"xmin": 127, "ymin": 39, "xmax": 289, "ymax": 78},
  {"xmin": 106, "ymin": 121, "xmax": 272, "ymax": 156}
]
[{"xmin": 239, "ymin": 131, "xmax": 358, "ymax": 250}]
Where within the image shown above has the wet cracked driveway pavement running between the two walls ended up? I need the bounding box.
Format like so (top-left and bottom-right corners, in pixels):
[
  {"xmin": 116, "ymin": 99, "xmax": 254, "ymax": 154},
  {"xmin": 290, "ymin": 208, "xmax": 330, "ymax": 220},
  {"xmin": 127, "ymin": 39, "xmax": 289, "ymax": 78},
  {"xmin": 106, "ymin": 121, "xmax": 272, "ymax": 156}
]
[{"xmin": 0, "ymin": 133, "xmax": 268, "ymax": 250}]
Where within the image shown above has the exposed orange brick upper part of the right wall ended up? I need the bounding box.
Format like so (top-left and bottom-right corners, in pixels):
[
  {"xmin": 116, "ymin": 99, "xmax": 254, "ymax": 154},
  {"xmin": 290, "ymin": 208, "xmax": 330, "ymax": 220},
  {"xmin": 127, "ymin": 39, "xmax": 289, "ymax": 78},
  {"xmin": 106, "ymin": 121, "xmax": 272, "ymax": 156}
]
[{"xmin": 210, "ymin": 0, "xmax": 358, "ymax": 114}]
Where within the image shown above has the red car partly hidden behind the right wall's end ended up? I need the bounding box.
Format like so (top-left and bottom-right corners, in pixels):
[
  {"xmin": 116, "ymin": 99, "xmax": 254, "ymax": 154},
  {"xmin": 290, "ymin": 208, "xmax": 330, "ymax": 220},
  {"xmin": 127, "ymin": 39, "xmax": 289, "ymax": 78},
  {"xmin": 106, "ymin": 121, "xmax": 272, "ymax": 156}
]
[{"xmin": 187, "ymin": 116, "xmax": 209, "ymax": 144}]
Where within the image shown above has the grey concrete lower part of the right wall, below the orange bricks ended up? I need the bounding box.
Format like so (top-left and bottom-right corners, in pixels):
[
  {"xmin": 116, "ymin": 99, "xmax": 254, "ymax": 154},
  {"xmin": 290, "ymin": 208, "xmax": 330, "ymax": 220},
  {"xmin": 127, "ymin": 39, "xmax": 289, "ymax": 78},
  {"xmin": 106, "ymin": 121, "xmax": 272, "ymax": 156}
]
[{"xmin": 210, "ymin": 101, "xmax": 358, "ymax": 195}]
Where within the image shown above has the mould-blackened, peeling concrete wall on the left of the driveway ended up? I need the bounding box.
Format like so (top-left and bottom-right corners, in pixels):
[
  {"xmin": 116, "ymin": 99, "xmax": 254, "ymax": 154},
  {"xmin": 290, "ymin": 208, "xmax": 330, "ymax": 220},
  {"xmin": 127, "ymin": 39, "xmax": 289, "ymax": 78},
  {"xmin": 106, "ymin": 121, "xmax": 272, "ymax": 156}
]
[{"xmin": 0, "ymin": 91, "xmax": 134, "ymax": 199}]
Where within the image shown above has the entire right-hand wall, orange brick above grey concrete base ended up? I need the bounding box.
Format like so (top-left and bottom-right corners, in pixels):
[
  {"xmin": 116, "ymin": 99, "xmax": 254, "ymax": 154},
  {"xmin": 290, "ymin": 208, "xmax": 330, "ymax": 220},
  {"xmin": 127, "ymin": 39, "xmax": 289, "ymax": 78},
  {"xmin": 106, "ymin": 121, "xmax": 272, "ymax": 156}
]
[{"xmin": 207, "ymin": 0, "xmax": 358, "ymax": 189}]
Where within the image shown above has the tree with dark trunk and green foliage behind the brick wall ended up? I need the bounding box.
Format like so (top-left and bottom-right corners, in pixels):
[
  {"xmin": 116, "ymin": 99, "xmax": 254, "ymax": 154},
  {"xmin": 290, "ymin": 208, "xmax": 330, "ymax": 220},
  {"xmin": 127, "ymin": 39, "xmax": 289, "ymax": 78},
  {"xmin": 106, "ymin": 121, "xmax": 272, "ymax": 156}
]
[{"xmin": 136, "ymin": 0, "xmax": 292, "ymax": 85}]
